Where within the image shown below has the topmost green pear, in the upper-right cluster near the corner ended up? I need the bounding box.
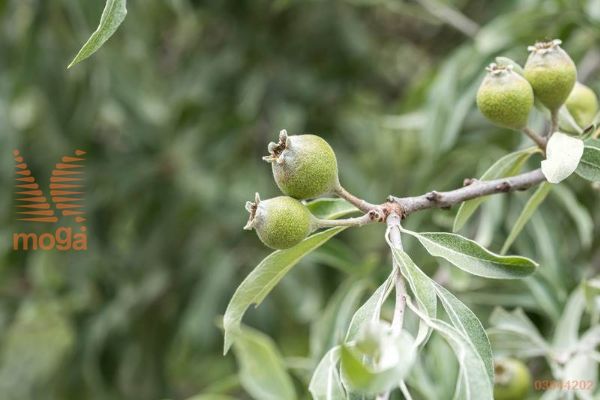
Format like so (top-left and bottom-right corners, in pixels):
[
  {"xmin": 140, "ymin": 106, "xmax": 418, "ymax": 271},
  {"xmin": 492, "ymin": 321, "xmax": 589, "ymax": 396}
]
[{"xmin": 524, "ymin": 40, "xmax": 577, "ymax": 112}]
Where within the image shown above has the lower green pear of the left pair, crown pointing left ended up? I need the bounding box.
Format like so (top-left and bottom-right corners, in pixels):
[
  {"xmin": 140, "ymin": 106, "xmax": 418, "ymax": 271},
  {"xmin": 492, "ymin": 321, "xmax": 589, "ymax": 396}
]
[{"xmin": 244, "ymin": 193, "xmax": 315, "ymax": 250}]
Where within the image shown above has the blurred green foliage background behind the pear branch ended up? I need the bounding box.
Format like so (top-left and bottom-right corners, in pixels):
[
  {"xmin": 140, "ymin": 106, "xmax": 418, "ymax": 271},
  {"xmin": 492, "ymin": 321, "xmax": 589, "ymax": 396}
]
[{"xmin": 0, "ymin": 0, "xmax": 600, "ymax": 400}]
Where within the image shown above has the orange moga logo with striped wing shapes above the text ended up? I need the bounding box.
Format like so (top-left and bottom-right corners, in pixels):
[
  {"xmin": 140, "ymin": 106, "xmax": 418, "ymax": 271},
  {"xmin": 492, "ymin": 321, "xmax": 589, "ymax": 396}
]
[{"xmin": 13, "ymin": 150, "xmax": 87, "ymax": 251}]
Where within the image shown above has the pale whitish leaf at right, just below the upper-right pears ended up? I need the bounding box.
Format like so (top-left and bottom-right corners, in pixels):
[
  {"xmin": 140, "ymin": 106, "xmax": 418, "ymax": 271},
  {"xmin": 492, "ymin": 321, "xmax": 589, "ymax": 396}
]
[{"xmin": 542, "ymin": 132, "xmax": 583, "ymax": 183}]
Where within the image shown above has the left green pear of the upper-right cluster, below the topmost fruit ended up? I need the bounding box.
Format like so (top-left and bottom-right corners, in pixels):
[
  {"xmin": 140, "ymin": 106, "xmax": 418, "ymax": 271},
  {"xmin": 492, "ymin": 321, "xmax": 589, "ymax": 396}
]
[{"xmin": 477, "ymin": 64, "xmax": 533, "ymax": 129}]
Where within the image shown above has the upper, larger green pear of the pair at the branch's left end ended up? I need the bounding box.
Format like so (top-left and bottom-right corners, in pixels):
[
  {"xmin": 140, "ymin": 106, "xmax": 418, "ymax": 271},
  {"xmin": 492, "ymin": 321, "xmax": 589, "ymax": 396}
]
[{"xmin": 263, "ymin": 130, "xmax": 339, "ymax": 199}]
